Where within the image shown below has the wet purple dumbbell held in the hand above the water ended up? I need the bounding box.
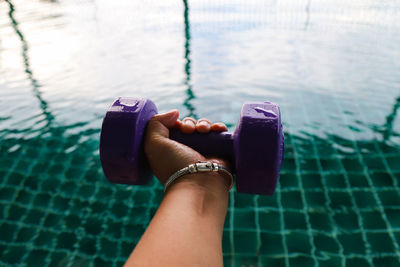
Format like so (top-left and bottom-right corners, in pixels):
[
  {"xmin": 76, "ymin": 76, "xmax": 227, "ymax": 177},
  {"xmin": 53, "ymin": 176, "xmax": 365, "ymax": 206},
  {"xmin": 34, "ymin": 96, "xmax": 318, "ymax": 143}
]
[{"xmin": 100, "ymin": 97, "xmax": 284, "ymax": 195}]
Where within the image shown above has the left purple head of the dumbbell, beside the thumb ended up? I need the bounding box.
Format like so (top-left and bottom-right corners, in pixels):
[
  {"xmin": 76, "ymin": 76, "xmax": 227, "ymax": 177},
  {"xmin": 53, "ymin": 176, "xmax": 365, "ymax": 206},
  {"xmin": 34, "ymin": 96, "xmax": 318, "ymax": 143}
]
[{"xmin": 100, "ymin": 97, "xmax": 157, "ymax": 185}]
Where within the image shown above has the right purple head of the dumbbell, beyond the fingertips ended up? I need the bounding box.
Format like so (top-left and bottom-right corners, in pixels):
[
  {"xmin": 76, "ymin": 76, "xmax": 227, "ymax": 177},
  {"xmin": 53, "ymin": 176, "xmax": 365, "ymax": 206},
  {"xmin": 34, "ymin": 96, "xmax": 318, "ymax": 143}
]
[{"xmin": 233, "ymin": 102, "xmax": 284, "ymax": 195}]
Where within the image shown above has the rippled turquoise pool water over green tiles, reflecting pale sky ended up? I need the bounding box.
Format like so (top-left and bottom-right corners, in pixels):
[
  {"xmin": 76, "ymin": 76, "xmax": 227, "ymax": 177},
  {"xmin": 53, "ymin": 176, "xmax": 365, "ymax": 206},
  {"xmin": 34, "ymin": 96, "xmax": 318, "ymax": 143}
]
[{"xmin": 0, "ymin": 0, "xmax": 400, "ymax": 266}]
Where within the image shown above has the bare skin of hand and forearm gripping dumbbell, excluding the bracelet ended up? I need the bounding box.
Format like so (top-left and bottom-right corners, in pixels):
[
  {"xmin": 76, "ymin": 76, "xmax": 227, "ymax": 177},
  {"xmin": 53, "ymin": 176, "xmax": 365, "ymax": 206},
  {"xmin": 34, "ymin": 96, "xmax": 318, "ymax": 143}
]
[{"xmin": 125, "ymin": 110, "xmax": 230, "ymax": 267}]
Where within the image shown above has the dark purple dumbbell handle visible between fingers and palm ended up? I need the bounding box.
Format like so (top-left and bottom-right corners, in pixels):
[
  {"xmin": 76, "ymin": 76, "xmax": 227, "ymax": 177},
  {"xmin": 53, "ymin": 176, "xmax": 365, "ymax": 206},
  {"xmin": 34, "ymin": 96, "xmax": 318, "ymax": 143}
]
[{"xmin": 170, "ymin": 129, "xmax": 234, "ymax": 164}]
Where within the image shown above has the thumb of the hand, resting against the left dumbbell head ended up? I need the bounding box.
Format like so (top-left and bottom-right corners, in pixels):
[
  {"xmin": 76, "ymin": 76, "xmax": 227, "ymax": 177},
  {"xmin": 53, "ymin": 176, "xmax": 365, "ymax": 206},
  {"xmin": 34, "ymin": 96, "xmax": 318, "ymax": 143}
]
[{"xmin": 147, "ymin": 109, "xmax": 179, "ymax": 137}]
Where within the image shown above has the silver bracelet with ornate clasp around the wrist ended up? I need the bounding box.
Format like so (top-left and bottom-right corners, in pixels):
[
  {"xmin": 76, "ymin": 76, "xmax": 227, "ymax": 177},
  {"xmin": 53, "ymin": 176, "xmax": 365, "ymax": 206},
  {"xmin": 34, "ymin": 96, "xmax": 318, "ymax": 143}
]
[{"xmin": 164, "ymin": 161, "xmax": 233, "ymax": 192}]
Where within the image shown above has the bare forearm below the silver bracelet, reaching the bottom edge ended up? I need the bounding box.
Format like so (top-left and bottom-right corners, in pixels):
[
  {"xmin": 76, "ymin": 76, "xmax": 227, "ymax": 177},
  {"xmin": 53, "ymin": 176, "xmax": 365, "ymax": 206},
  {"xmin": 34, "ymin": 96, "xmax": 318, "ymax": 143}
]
[{"xmin": 126, "ymin": 173, "xmax": 228, "ymax": 266}]
